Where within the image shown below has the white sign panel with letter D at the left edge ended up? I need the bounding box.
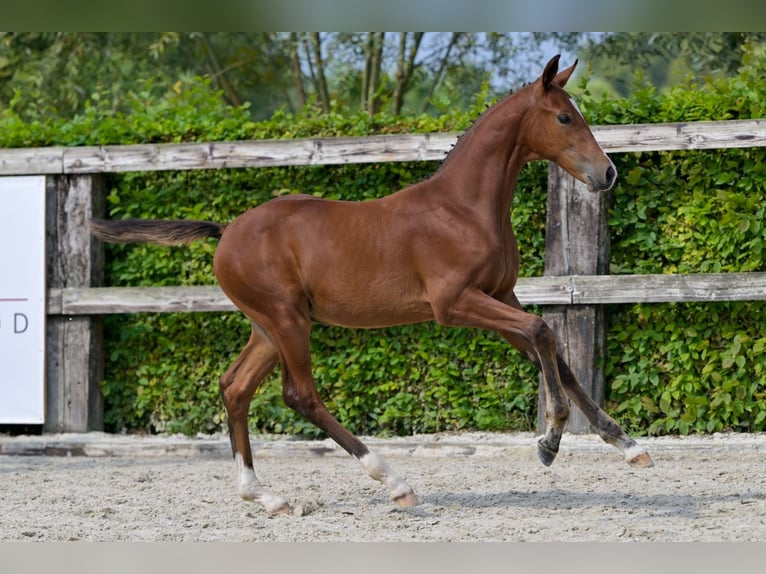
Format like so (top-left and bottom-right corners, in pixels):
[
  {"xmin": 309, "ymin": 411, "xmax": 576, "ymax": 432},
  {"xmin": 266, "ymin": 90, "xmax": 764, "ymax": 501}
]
[{"xmin": 0, "ymin": 176, "xmax": 45, "ymax": 424}]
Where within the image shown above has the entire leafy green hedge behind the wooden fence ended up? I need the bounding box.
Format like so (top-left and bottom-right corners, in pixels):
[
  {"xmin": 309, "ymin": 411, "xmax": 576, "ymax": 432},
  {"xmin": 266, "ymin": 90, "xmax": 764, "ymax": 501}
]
[{"xmin": 0, "ymin": 57, "xmax": 766, "ymax": 435}]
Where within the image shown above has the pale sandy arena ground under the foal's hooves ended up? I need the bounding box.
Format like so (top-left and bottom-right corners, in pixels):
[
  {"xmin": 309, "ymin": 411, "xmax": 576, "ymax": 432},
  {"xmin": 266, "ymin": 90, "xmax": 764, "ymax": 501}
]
[{"xmin": 0, "ymin": 433, "xmax": 766, "ymax": 542}]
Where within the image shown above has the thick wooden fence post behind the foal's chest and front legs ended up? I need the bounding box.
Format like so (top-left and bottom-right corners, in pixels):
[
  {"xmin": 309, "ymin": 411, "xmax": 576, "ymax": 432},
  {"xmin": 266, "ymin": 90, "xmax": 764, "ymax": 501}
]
[{"xmin": 538, "ymin": 164, "xmax": 611, "ymax": 433}]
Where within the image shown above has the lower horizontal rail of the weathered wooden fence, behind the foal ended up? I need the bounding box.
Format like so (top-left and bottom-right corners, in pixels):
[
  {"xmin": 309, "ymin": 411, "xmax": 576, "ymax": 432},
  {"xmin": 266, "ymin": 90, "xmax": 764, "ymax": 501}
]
[{"xmin": 48, "ymin": 273, "xmax": 766, "ymax": 315}]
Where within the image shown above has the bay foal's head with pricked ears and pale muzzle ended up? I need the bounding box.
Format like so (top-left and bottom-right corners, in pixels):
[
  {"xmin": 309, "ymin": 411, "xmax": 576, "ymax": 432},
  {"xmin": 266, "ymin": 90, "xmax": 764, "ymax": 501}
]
[{"xmin": 521, "ymin": 56, "xmax": 617, "ymax": 192}]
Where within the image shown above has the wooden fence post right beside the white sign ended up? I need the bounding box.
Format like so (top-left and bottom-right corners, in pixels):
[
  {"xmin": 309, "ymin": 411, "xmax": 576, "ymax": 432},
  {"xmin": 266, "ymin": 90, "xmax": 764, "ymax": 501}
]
[{"xmin": 44, "ymin": 175, "xmax": 105, "ymax": 432}]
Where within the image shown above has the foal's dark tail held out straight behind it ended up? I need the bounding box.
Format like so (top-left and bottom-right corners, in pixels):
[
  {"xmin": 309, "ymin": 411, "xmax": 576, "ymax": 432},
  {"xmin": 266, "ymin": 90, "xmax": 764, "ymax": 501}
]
[{"xmin": 90, "ymin": 219, "xmax": 226, "ymax": 245}]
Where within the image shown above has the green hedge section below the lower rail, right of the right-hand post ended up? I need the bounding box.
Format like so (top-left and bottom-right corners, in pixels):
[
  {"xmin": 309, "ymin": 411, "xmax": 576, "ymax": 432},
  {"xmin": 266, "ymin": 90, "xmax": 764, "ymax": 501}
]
[{"xmin": 606, "ymin": 302, "xmax": 766, "ymax": 434}]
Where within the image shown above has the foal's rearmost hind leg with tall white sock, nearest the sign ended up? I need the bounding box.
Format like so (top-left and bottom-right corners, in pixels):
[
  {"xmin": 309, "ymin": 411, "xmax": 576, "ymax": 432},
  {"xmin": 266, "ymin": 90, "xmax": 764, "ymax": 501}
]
[{"xmin": 220, "ymin": 324, "xmax": 290, "ymax": 513}]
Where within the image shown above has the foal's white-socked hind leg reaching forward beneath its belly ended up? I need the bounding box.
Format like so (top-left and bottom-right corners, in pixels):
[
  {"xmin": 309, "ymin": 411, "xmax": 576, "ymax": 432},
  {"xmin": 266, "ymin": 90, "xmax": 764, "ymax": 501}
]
[{"xmin": 273, "ymin": 310, "xmax": 418, "ymax": 507}]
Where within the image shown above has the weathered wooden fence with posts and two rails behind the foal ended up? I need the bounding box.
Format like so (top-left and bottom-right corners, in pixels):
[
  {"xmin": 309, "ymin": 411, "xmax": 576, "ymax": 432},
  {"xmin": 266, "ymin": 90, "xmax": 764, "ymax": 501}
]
[{"xmin": 0, "ymin": 120, "xmax": 766, "ymax": 432}]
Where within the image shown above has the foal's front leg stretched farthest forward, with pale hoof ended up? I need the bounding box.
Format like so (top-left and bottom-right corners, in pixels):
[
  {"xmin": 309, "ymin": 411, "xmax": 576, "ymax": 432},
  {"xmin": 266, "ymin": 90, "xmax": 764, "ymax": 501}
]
[{"xmin": 557, "ymin": 355, "xmax": 654, "ymax": 467}]
